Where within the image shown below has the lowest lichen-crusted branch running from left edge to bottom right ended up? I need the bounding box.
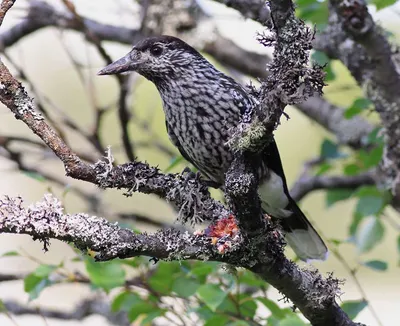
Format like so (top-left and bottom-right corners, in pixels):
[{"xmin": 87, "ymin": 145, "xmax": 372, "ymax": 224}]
[{"xmin": 0, "ymin": 195, "xmax": 356, "ymax": 326}]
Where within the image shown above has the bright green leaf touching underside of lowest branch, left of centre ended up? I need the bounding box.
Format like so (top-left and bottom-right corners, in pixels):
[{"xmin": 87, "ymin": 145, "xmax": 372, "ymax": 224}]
[{"xmin": 85, "ymin": 257, "xmax": 125, "ymax": 291}]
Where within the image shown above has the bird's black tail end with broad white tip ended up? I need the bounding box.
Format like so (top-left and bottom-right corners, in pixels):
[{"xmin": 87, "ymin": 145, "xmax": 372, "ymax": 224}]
[{"xmin": 279, "ymin": 198, "xmax": 328, "ymax": 261}]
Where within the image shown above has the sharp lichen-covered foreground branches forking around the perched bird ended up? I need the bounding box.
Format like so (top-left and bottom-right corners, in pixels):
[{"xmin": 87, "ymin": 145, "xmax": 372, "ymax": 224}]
[{"xmin": 0, "ymin": 0, "xmax": 355, "ymax": 326}]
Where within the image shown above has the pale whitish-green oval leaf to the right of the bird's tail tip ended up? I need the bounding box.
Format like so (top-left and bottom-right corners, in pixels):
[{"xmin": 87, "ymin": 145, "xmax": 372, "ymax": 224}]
[{"xmin": 356, "ymin": 216, "xmax": 385, "ymax": 254}]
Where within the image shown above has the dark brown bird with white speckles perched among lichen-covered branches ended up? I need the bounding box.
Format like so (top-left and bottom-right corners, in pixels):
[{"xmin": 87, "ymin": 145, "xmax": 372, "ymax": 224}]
[{"xmin": 98, "ymin": 35, "xmax": 328, "ymax": 262}]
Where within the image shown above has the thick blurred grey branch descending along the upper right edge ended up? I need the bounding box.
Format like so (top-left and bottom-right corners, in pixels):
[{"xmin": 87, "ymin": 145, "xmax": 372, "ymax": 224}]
[{"xmin": 315, "ymin": 0, "xmax": 400, "ymax": 202}]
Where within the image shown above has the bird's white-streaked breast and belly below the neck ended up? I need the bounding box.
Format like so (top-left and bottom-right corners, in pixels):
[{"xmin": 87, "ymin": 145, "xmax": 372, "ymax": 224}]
[{"xmin": 163, "ymin": 90, "xmax": 239, "ymax": 183}]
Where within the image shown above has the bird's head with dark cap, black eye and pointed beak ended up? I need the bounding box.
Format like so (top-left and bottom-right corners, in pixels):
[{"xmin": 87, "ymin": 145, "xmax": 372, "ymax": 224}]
[{"xmin": 98, "ymin": 35, "xmax": 204, "ymax": 83}]
